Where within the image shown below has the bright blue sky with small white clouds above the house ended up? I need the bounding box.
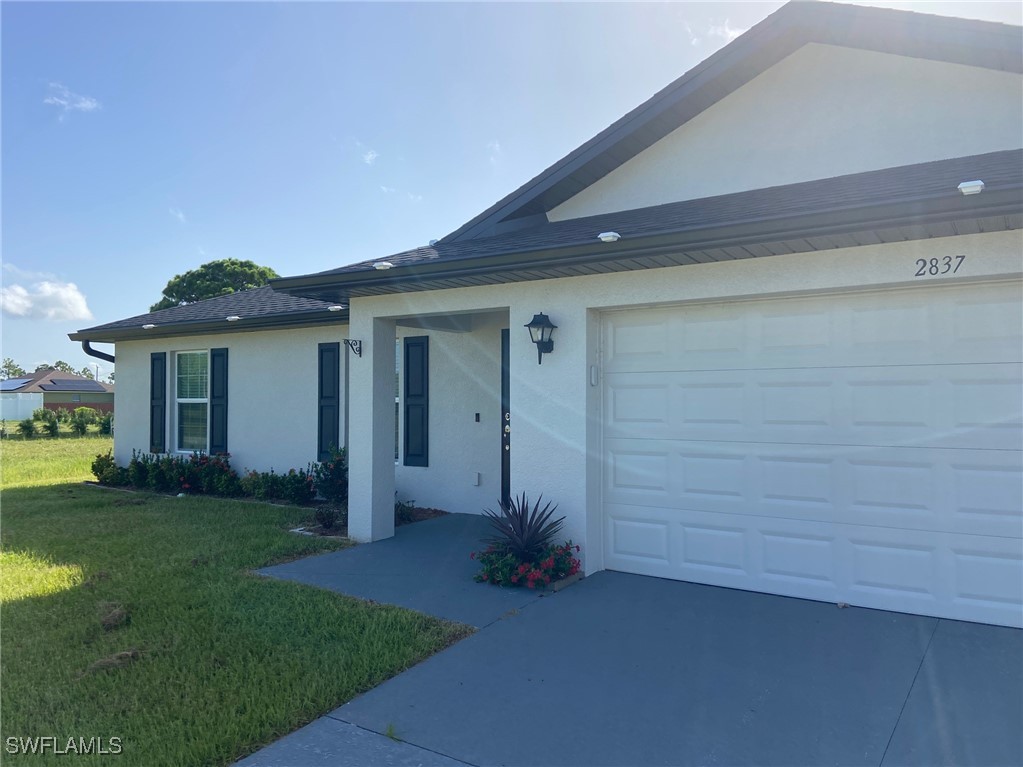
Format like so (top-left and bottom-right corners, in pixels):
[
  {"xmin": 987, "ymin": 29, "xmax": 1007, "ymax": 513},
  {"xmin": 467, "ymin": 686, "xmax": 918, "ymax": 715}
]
[{"xmin": 0, "ymin": 0, "xmax": 1023, "ymax": 377}]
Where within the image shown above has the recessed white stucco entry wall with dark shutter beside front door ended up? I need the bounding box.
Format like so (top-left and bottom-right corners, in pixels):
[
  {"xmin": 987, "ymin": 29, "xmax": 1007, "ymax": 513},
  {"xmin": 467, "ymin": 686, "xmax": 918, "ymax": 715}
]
[{"xmin": 395, "ymin": 315, "xmax": 506, "ymax": 513}]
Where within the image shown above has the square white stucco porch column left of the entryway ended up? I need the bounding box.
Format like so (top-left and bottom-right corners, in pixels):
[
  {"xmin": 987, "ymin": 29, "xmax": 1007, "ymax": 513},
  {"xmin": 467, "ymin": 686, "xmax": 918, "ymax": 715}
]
[{"xmin": 348, "ymin": 314, "xmax": 395, "ymax": 543}]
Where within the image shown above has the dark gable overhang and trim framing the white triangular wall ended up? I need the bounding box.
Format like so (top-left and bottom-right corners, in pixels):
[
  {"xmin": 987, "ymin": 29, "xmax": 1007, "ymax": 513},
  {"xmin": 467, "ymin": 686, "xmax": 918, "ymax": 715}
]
[{"xmin": 440, "ymin": 2, "xmax": 1023, "ymax": 242}]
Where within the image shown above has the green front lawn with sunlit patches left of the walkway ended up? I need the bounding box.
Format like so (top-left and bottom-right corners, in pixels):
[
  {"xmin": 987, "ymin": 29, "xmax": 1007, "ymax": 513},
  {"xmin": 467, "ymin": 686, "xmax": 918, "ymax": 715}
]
[{"xmin": 0, "ymin": 439, "xmax": 466, "ymax": 765}]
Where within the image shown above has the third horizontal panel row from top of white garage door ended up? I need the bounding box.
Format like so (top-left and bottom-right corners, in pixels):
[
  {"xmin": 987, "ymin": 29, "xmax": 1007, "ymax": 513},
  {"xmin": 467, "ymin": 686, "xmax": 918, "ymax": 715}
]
[{"xmin": 604, "ymin": 440, "xmax": 1023, "ymax": 539}]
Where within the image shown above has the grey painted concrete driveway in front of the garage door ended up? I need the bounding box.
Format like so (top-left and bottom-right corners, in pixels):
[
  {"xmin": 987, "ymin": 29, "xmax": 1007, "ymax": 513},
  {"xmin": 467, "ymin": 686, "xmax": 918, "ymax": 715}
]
[{"xmin": 241, "ymin": 523, "xmax": 1023, "ymax": 767}]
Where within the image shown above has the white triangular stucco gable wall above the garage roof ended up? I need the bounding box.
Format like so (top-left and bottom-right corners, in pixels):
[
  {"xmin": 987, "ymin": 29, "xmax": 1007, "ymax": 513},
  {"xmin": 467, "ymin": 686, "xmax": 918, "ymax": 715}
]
[{"xmin": 548, "ymin": 43, "xmax": 1023, "ymax": 221}]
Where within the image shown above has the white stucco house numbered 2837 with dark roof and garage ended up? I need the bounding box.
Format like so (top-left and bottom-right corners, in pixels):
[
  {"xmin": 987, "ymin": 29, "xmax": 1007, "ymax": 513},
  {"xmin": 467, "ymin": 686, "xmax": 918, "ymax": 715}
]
[{"xmin": 72, "ymin": 3, "xmax": 1023, "ymax": 626}]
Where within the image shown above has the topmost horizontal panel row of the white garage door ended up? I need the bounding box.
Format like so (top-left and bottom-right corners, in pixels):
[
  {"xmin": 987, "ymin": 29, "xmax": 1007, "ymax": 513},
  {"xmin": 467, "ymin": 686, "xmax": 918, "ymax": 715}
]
[{"xmin": 604, "ymin": 281, "xmax": 1023, "ymax": 372}]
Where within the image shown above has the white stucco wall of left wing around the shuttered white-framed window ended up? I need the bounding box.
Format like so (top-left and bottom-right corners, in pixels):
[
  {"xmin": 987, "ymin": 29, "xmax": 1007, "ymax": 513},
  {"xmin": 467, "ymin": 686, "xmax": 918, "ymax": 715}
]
[{"xmin": 114, "ymin": 324, "xmax": 348, "ymax": 473}]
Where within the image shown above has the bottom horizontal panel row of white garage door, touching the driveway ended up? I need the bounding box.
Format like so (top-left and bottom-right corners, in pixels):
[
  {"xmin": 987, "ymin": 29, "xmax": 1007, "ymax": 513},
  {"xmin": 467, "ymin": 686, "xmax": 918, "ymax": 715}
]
[{"xmin": 606, "ymin": 505, "xmax": 1023, "ymax": 626}]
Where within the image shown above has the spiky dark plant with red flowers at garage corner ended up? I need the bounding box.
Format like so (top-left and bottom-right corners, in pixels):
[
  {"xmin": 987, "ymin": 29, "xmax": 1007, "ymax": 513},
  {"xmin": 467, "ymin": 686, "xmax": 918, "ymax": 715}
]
[{"xmin": 471, "ymin": 493, "xmax": 580, "ymax": 589}]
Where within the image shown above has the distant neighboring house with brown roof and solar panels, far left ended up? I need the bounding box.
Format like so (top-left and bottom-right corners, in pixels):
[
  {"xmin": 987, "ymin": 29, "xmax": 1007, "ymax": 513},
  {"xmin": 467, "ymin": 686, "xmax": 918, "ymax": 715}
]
[{"xmin": 0, "ymin": 367, "xmax": 114, "ymax": 420}]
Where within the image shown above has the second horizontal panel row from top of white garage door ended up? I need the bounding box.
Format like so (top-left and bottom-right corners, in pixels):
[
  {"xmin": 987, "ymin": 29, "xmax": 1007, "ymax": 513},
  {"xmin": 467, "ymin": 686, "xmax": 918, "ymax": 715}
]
[{"xmin": 605, "ymin": 364, "xmax": 1023, "ymax": 450}]
